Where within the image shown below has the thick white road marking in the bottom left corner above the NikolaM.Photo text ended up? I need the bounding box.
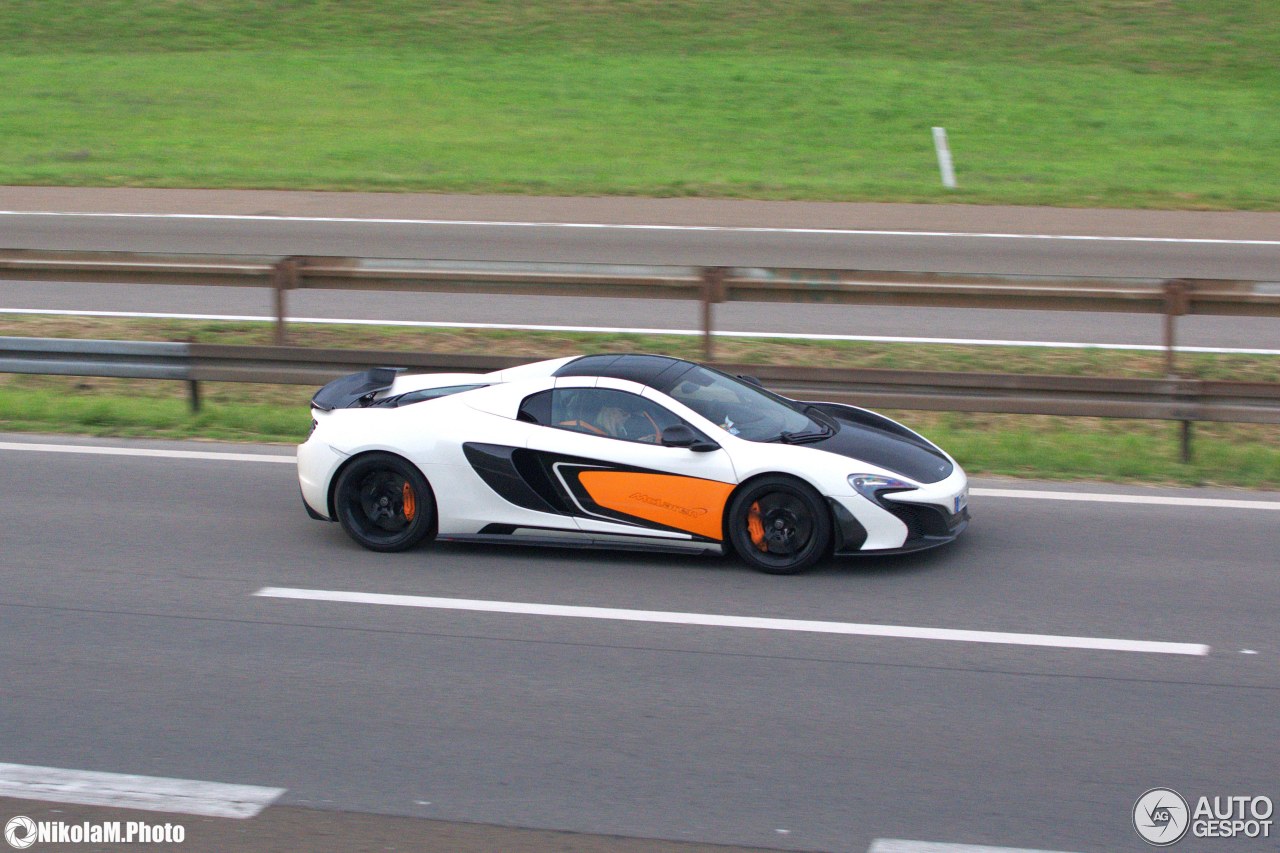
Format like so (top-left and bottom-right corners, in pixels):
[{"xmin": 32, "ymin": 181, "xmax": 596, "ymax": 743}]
[{"xmin": 0, "ymin": 763, "xmax": 285, "ymax": 818}]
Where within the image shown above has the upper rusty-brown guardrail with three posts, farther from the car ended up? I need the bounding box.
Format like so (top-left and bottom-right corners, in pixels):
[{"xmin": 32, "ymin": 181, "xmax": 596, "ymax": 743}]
[{"xmin": 0, "ymin": 250, "xmax": 1280, "ymax": 374}]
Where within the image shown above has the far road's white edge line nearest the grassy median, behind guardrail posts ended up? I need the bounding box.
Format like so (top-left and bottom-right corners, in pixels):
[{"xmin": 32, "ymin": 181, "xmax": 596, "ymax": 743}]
[{"xmin": 0, "ymin": 309, "xmax": 1280, "ymax": 355}]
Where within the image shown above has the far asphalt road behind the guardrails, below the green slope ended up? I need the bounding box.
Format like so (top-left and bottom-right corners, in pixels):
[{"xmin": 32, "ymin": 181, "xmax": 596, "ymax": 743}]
[{"xmin": 0, "ymin": 187, "xmax": 1280, "ymax": 348}]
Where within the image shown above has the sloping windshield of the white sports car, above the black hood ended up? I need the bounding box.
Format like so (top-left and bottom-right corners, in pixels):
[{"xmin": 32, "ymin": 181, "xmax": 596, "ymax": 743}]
[{"xmin": 667, "ymin": 365, "xmax": 831, "ymax": 442}]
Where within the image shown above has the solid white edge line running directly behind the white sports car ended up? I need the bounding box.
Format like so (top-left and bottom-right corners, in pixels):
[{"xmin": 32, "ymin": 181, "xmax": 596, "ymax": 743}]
[{"xmin": 0, "ymin": 442, "xmax": 1280, "ymax": 511}]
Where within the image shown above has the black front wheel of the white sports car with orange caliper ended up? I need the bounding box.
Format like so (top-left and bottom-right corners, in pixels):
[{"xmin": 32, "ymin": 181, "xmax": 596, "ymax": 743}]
[{"xmin": 724, "ymin": 475, "xmax": 831, "ymax": 575}]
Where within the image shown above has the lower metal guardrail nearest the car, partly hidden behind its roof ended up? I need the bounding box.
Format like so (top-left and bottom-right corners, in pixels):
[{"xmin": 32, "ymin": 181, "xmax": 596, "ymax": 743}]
[{"xmin": 0, "ymin": 337, "xmax": 1280, "ymax": 438}]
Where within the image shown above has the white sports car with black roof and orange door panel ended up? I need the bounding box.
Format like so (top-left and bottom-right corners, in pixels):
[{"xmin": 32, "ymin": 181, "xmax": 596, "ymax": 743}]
[{"xmin": 298, "ymin": 355, "xmax": 969, "ymax": 574}]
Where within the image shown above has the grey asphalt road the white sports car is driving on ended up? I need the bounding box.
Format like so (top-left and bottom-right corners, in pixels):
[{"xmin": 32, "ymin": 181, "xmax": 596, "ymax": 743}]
[{"xmin": 0, "ymin": 437, "xmax": 1280, "ymax": 852}]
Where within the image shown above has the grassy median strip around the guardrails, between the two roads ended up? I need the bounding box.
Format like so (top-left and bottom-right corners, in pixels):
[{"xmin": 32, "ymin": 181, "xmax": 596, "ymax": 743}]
[{"xmin": 0, "ymin": 319, "xmax": 1280, "ymax": 488}]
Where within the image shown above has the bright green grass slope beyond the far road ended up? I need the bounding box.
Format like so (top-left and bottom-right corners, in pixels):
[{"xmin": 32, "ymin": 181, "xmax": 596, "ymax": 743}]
[{"xmin": 0, "ymin": 0, "xmax": 1280, "ymax": 209}]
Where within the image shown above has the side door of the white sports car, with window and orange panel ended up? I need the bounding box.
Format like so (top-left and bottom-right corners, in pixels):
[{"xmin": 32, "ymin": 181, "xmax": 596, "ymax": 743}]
[{"xmin": 521, "ymin": 377, "xmax": 737, "ymax": 543}]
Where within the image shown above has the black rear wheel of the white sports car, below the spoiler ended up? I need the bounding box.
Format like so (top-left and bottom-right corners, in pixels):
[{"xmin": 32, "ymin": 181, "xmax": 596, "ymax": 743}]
[{"xmin": 333, "ymin": 453, "xmax": 435, "ymax": 551}]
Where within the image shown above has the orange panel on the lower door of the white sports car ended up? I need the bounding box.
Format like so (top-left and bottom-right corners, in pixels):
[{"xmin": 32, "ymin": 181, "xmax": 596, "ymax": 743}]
[{"xmin": 577, "ymin": 471, "xmax": 733, "ymax": 542}]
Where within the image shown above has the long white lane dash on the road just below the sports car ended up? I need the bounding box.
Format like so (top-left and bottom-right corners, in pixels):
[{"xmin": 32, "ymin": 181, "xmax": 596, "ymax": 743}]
[{"xmin": 253, "ymin": 587, "xmax": 1210, "ymax": 656}]
